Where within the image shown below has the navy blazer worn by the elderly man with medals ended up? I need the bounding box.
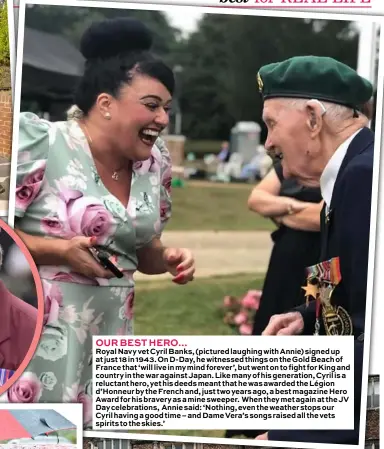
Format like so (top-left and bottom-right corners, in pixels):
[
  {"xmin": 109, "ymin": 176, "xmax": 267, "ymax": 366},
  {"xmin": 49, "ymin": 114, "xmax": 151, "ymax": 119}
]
[{"xmin": 268, "ymin": 128, "xmax": 374, "ymax": 444}]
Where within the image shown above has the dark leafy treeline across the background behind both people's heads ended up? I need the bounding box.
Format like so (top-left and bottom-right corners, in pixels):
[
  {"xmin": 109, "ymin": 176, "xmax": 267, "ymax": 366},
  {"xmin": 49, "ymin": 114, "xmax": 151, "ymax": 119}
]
[{"xmin": 23, "ymin": 5, "xmax": 358, "ymax": 139}]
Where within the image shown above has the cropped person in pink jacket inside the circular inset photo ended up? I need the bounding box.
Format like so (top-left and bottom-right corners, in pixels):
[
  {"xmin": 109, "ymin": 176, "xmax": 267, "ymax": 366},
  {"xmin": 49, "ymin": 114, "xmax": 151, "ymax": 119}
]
[{"xmin": 0, "ymin": 246, "xmax": 37, "ymax": 371}]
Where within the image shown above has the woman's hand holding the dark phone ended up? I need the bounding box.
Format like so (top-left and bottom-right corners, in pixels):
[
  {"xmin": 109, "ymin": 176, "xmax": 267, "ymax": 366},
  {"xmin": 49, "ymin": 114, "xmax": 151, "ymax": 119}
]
[{"xmin": 60, "ymin": 237, "xmax": 115, "ymax": 279}]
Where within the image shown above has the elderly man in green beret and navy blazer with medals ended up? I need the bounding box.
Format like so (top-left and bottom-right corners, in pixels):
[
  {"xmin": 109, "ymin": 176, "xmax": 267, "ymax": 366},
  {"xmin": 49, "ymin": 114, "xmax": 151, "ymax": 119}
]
[{"xmin": 258, "ymin": 56, "xmax": 374, "ymax": 444}]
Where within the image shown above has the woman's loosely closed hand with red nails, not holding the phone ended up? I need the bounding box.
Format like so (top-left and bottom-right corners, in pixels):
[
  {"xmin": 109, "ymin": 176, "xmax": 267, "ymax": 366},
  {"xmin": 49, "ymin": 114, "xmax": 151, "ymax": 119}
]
[{"xmin": 163, "ymin": 248, "xmax": 195, "ymax": 284}]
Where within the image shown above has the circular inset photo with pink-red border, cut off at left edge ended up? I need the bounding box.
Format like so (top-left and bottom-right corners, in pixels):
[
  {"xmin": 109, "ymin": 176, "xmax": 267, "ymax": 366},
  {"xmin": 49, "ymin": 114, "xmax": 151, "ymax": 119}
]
[{"xmin": 0, "ymin": 220, "xmax": 44, "ymax": 395}]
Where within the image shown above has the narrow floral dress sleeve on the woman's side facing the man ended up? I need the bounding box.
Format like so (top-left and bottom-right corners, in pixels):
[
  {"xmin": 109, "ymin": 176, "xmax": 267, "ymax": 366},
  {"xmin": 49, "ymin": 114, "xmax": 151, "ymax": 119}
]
[{"xmin": 156, "ymin": 139, "xmax": 172, "ymax": 234}]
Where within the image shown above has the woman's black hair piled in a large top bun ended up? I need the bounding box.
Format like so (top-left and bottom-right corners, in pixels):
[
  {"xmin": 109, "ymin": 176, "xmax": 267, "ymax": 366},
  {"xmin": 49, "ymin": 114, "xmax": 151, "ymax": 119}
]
[{"xmin": 75, "ymin": 17, "xmax": 175, "ymax": 115}]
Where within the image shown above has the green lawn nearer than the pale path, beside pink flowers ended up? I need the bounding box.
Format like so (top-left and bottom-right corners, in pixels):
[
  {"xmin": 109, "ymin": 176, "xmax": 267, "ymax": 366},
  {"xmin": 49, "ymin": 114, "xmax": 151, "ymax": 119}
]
[{"xmin": 133, "ymin": 274, "xmax": 263, "ymax": 438}]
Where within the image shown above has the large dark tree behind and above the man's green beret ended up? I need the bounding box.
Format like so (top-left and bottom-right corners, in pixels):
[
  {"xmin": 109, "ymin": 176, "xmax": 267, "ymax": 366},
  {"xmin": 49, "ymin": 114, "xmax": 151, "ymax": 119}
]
[{"xmin": 181, "ymin": 14, "xmax": 357, "ymax": 139}]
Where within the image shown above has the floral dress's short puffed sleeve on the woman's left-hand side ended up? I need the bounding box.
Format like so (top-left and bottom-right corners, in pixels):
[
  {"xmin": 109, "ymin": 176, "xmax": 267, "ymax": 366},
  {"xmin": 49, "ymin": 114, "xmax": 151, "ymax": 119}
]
[{"xmin": 15, "ymin": 112, "xmax": 50, "ymax": 217}]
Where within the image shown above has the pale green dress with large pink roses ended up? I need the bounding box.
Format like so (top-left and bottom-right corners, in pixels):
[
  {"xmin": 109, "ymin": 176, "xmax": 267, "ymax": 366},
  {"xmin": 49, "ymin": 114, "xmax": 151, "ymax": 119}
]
[{"xmin": 2, "ymin": 113, "xmax": 171, "ymax": 428}]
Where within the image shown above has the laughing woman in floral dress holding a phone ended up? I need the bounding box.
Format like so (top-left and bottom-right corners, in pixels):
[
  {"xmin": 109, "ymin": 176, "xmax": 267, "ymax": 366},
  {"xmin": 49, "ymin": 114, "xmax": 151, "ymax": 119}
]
[{"xmin": 7, "ymin": 18, "xmax": 194, "ymax": 428}]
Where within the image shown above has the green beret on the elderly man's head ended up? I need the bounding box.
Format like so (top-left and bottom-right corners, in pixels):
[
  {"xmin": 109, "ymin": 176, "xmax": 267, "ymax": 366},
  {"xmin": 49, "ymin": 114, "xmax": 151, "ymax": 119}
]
[{"xmin": 257, "ymin": 56, "xmax": 373, "ymax": 109}]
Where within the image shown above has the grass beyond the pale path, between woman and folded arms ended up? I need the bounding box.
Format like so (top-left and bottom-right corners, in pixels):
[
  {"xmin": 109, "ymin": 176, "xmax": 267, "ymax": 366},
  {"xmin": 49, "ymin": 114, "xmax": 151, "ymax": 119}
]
[{"xmin": 166, "ymin": 181, "xmax": 274, "ymax": 231}]
